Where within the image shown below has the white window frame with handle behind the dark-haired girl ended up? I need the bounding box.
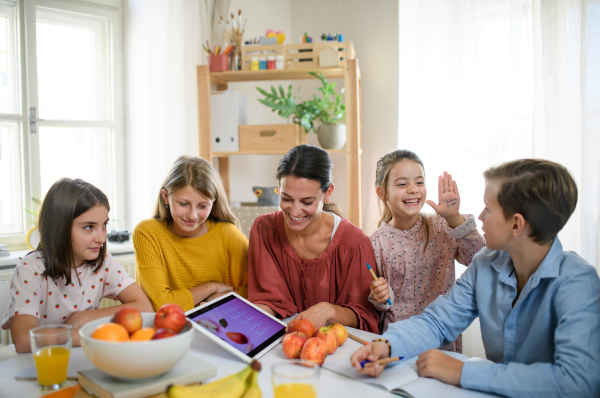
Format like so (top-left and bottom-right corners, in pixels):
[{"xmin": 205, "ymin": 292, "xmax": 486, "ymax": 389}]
[{"xmin": 0, "ymin": 0, "xmax": 126, "ymax": 251}]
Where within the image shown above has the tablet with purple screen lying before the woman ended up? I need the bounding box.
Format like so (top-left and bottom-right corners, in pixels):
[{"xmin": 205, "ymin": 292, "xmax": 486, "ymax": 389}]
[{"xmin": 187, "ymin": 295, "xmax": 285, "ymax": 358}]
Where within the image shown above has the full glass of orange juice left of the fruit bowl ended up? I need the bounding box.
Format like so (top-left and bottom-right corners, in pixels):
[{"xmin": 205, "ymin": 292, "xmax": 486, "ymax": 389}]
[{"xmin": 29, "ymin": 325, "xmax": 73, "ymax": 390}]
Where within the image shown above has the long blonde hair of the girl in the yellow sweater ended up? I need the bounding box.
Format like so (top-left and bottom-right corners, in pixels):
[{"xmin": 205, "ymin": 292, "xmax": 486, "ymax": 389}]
[{"xmin": 154, "ymin": 156, "xmax": 237, "ymax": 225}]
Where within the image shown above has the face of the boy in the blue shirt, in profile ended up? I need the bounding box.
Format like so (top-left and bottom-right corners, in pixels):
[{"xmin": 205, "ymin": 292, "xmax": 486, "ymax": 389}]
[{"xmin": 479, "ymin": 180, "xmax": 512, "ymax": 250}]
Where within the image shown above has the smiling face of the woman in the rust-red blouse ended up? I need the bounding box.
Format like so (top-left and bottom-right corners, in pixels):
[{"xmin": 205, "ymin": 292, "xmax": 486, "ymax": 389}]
[{"xmin": 279, "ymin": 176, "xmax": 333, "ymax": 231}]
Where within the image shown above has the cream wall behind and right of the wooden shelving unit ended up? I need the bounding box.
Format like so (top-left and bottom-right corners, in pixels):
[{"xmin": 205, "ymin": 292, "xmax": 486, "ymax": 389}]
[{"xmin": 224, "ymin": 0, "xmax": 398, "ymax": 233}]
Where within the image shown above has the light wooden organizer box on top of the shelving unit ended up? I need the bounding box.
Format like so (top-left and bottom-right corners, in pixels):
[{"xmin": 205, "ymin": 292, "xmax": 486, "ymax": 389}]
[{"xmin": 241, "ymin": 41, "xmax": 355, "ymax": 70}]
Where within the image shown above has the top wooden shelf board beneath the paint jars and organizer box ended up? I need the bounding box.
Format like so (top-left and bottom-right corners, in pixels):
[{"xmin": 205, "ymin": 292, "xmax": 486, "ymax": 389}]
[{"xmin": 210, "ymin": 67, "xmax": 344, "ymax": 84}]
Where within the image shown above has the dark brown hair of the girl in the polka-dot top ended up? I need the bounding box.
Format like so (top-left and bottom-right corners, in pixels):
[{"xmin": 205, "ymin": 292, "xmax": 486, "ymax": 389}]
[{"xmin": 36, "ymin": 178, "xmax": 110, "ymax": 285}]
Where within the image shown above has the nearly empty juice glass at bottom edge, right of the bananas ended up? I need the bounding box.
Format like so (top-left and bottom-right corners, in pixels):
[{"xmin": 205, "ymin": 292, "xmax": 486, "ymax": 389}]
[{"xmin": 271, "ymin": 359, "xmax": 320, "ymax": 398}]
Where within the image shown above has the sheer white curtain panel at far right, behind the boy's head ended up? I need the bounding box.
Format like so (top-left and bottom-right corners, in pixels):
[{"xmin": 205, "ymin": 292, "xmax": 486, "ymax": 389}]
[{"xmin": 533, "ymin": 0, "xmax": 600, "ymax": 271}]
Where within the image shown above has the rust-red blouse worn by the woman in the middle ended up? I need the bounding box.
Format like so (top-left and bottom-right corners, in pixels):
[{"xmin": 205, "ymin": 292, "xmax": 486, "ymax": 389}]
[{"xmin": 248, "ymin": 210, "xmax": 379, "ymax": 333}]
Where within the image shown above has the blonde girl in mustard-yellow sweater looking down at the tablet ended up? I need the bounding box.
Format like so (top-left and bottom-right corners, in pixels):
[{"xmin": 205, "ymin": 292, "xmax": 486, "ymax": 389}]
[{"xmin": 133, "ymin": 156, "xmax": 248, "ymax": 311}]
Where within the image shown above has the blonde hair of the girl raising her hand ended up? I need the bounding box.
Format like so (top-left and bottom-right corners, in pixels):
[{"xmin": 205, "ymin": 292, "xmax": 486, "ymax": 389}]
[{"xmin": 375, "ymin": 149, "xmax": 429, "ymax": 252}]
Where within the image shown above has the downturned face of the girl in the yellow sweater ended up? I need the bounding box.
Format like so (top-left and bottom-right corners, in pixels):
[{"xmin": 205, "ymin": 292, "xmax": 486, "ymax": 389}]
[{"xmin": 161, "ymin": 185, "xmax": 213, "ymax": 238}]
